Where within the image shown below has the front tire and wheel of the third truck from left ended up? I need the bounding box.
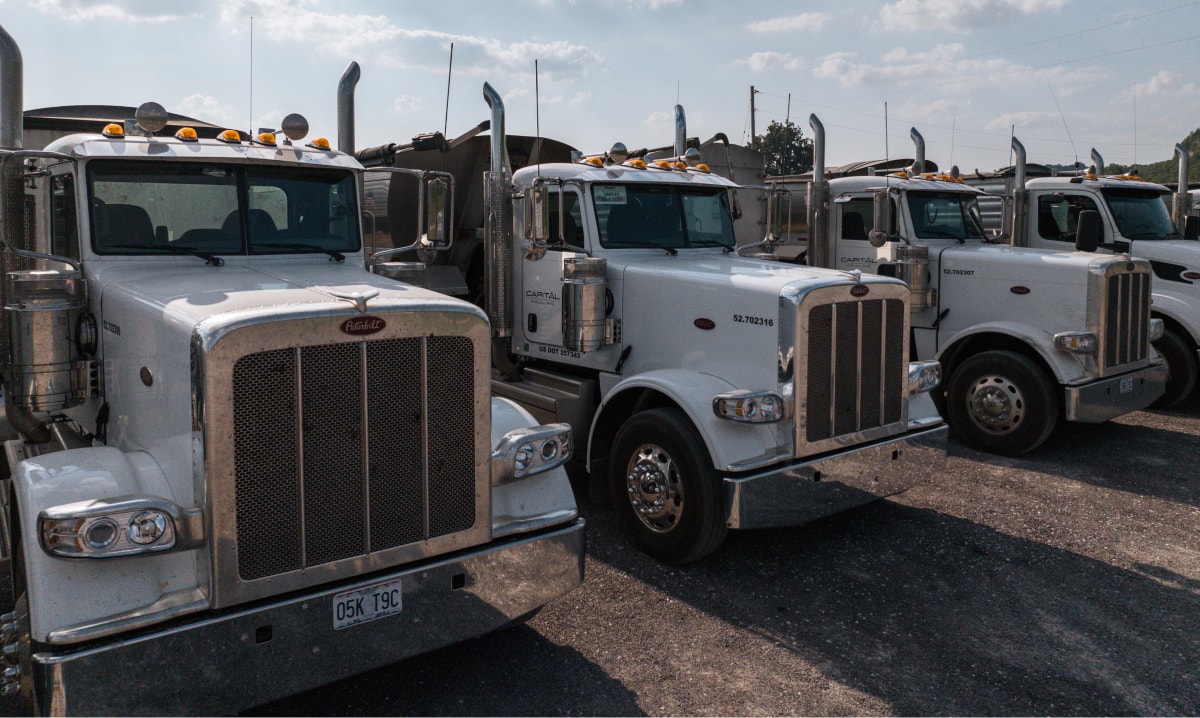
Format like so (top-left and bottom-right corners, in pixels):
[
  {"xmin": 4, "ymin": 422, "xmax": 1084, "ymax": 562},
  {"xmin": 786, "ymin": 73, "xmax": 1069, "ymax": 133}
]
[{"xmin": 946, "ymin": 351, "xmax": 1058, "ymax": 456}]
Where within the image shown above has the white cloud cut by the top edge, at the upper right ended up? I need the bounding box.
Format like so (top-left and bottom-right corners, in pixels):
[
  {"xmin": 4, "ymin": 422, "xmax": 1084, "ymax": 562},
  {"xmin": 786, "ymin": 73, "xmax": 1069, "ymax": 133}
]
[{"xmin": 880, "ymin": 0, "xmax": 1069, "ymax": 32}]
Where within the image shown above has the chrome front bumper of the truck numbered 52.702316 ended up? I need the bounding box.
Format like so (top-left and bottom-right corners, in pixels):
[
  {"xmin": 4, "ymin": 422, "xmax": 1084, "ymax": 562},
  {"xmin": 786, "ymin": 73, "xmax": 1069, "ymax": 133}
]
[{"xmin": 725, "ymin": 424, "xmax": 949, "ymax": 528}]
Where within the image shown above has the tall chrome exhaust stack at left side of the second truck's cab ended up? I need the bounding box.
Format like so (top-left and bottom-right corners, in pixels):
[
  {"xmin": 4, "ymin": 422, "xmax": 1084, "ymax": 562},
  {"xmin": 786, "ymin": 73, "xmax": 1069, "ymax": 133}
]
[{"xmin": 484, "ymin": 83, "xmax": 514, "ymax": 343}]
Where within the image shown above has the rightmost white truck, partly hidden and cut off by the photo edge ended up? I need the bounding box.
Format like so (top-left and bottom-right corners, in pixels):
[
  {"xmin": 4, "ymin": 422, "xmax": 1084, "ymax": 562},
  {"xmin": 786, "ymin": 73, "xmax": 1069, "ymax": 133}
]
[{"xmin": 972, "ymin": 137, "xmax": 1200, "ymax": 407}]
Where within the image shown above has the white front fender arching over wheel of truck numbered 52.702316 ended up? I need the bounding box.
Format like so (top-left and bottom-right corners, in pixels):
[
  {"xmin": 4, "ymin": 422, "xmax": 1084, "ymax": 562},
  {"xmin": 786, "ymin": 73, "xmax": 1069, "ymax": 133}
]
[{"xmin": 588, "ymin": 369, "xmax": 792, "ymax": 472}]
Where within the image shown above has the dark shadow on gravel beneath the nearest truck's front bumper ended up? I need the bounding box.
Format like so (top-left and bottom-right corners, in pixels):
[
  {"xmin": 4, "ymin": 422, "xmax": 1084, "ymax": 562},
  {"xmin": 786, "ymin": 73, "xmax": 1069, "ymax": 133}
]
[{"xmin": 244, "ymin": 618, "xmax": 644, "ymax": 716}]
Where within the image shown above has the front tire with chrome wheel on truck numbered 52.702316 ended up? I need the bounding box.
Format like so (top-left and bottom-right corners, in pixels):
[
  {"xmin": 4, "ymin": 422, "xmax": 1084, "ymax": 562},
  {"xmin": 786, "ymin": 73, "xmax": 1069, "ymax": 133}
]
[{"xmin": 608, "ymin": 408, "xmax": 727, "ymax": 564}]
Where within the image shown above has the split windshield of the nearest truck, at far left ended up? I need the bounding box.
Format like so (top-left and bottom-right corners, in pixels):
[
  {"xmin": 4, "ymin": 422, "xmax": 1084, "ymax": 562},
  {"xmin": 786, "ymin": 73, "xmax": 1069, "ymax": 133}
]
[{"xmin": 88, "ymin": 161, "xmax": 359, "ymax": 255}]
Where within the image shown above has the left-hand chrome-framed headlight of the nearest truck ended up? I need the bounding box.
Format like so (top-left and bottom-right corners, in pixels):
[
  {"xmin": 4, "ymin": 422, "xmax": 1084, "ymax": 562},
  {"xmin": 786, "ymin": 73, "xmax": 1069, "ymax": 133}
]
[{"xmin": 37, "ymin": 496, "xmax": 202, "ymax": 558}]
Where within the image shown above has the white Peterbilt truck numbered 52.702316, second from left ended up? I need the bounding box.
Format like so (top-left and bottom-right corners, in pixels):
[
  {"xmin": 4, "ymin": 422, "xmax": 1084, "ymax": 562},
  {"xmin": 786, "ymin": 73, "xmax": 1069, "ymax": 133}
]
[{"xmin": 343, "ymin": 77, "xmax": 947, "ymax": 563}]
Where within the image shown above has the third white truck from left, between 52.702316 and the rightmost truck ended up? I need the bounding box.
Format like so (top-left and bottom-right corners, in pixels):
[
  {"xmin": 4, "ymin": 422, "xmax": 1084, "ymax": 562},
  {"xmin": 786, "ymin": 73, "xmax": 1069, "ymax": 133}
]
[{"xmin": 760, "ymin": 115, "xmax": 1166, "ymax": 455}]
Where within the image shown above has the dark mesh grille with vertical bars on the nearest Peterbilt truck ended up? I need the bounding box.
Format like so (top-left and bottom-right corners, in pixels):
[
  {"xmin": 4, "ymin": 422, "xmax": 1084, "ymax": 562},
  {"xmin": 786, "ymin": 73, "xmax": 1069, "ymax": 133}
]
[{"xmin": 233, "ymin": 336, "xmax": 475, "ymax": 581}]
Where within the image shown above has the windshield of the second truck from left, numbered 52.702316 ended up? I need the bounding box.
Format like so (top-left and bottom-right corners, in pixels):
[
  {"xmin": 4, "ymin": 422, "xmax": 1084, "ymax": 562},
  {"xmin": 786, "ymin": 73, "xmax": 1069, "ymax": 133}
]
[{"xmin": 592, "ymin": 184, "xmax": 734, "ymax": 249}]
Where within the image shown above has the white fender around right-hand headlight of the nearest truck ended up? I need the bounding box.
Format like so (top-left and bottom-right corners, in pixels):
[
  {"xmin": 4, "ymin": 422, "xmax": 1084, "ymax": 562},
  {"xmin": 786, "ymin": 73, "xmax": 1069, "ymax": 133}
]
[{"xmin": 492, "ymin": 397, "xmax": 578, "ymax": 538}]
